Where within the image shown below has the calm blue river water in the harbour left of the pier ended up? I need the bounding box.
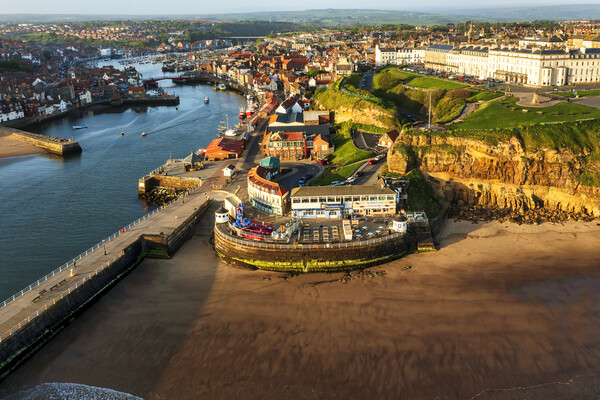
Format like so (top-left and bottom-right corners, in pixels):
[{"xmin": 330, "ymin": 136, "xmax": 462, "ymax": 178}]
[{"xmin": 0, "ymin": 64, "xmax": 245, "ymax": 301}]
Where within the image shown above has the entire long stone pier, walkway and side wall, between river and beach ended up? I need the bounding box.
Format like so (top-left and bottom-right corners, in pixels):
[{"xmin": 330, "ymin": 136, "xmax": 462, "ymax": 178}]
[{"xmin": 0, "ymin": 191, "xmax": 210, "ymax": 379}]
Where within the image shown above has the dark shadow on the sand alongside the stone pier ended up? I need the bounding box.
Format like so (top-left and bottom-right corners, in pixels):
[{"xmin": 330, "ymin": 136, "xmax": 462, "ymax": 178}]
[{"xmin": 0, "ymin": 202, "xmax": 220, "ymax": 398}]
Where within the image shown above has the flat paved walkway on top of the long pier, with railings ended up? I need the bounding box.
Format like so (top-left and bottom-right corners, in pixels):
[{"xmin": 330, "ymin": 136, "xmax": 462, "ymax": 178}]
[{"xmin": 0, "ymin": 190, "xmax": 209, "ymax": 343}]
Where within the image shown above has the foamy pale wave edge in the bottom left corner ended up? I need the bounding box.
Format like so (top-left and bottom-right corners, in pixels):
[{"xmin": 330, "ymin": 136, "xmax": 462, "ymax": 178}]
[{"xmin": 2, "ymin": 383, "xmax": 143, "ymax": 400}]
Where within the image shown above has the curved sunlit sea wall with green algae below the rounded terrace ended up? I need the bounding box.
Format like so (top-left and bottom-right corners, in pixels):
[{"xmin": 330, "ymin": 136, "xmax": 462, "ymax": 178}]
[{"xmin": 214, "ymin": 224, "xmax": 408, "ymax": 272}]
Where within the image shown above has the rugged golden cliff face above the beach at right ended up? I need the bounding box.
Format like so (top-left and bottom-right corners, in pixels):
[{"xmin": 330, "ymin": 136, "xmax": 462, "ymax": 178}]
[{"xmin": 388, "ymin": 135, "xmax": 600, "ymax": 216}]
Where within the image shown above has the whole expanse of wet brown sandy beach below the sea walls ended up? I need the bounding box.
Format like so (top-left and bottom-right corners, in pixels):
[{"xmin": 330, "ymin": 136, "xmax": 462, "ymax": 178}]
[{"xmin": 0, "ymin": 211, "xmax": 600, "ymax": 400}]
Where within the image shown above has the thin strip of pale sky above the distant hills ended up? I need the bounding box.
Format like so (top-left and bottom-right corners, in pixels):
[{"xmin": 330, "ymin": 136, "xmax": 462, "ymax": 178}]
[{"xmin": 0, "ymin": 0, "xmax": 598, "ymax": 15}]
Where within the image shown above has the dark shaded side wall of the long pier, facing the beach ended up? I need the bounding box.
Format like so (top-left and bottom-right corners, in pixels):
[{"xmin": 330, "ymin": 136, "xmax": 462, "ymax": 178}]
[{"xmin": 0, "ymin": 199, "xmax": 210, "ymax": 379}]
